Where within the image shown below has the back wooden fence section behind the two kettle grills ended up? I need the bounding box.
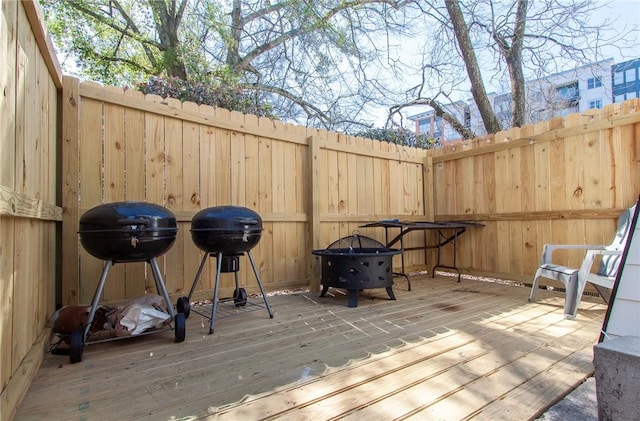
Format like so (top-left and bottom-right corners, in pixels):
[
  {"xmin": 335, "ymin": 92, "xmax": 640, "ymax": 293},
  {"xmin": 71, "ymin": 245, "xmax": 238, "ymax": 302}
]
[{"xmin": 63, "ymin": 78, "xmax": 426, "ymax": 303}]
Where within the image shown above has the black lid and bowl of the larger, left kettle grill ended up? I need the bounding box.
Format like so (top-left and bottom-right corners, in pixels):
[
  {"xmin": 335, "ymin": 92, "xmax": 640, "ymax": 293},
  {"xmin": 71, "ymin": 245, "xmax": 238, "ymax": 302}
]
[{"xmin": 78, "ymin": 202, "xmax": 178, "ymax": 262}]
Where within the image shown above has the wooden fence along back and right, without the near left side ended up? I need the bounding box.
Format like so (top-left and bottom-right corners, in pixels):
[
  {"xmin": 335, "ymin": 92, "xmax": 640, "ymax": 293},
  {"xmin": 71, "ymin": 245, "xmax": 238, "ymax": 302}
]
[{"xmin": 62, "ymin": 78, "xmax": 640, "ymax": 303}]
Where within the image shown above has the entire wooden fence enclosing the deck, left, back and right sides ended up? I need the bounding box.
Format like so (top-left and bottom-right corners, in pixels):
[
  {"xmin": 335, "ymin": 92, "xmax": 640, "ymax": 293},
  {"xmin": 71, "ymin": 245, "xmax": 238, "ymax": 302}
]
[{"xmin": 0, "ymin": 0, "xmax": 640, "ymax": 419}]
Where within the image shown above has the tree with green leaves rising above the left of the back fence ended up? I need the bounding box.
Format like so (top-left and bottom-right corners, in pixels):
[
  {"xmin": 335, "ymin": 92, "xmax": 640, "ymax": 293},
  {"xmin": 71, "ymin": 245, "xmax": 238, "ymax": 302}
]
[{"xmin": 43, "ymin": 0, "xmax": 408, "ymax": 129}]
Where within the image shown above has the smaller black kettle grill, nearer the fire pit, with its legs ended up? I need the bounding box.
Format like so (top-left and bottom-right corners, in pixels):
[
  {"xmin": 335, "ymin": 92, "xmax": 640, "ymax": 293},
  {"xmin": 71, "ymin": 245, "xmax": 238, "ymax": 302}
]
[{"xmin": 177, "ymin": 206, "xmax": 273, "ymax": 334}]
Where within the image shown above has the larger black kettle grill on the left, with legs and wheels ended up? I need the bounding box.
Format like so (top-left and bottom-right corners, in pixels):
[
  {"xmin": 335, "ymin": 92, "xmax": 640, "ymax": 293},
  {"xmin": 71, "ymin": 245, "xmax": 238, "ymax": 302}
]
[{"xmin": 70, "ymin": 202, "xmax": 185, "ymax": 362}]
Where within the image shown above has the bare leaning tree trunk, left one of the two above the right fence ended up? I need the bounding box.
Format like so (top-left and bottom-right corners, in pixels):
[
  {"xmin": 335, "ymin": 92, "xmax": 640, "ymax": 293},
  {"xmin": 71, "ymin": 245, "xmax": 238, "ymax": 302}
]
[{"xmin": 445, "ymin": 0, "xmax": 502, "ymax": 133}]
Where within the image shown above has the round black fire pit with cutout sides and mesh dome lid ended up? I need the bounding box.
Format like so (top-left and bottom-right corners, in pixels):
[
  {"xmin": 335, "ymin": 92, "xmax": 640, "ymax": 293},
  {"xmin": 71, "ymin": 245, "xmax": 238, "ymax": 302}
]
[{"xmin": 312, "ymin": 234, "xmax": 401, "ymax": 307}]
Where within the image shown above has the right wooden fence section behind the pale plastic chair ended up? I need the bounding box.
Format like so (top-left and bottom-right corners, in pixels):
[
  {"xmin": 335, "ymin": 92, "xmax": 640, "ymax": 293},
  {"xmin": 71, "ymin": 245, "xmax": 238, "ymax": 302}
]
[{"xmin": 424, "ymin": 104, "xmax": 640, "ymax": 282}]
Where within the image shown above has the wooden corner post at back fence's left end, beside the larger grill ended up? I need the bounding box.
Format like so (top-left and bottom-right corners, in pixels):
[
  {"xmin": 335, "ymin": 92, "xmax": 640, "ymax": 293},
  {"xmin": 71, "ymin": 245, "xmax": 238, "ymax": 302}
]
[{"xmin": 61, "ymin": 76, "xmax": 80, "ymax": 305}]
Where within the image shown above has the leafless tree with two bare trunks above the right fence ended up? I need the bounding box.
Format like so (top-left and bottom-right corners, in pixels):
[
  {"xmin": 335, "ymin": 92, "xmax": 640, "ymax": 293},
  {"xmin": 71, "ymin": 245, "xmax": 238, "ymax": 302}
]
[{"xmin": 390, "ymin": 0, "xmax": 630, "ymax": 138}]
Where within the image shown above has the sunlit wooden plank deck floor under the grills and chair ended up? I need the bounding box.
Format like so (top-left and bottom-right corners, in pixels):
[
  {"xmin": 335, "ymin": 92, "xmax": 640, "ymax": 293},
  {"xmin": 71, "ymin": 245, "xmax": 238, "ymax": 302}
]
[{"xmin": 15, "ymin": 276, "xmax": 606, "ymax": 420}]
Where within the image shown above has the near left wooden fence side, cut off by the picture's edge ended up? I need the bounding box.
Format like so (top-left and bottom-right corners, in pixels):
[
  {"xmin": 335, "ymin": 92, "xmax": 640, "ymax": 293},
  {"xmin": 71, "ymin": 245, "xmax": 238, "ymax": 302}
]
[{"xmin": 0, "ymin": 0, "xmax": 62, "ymax": 420}]
